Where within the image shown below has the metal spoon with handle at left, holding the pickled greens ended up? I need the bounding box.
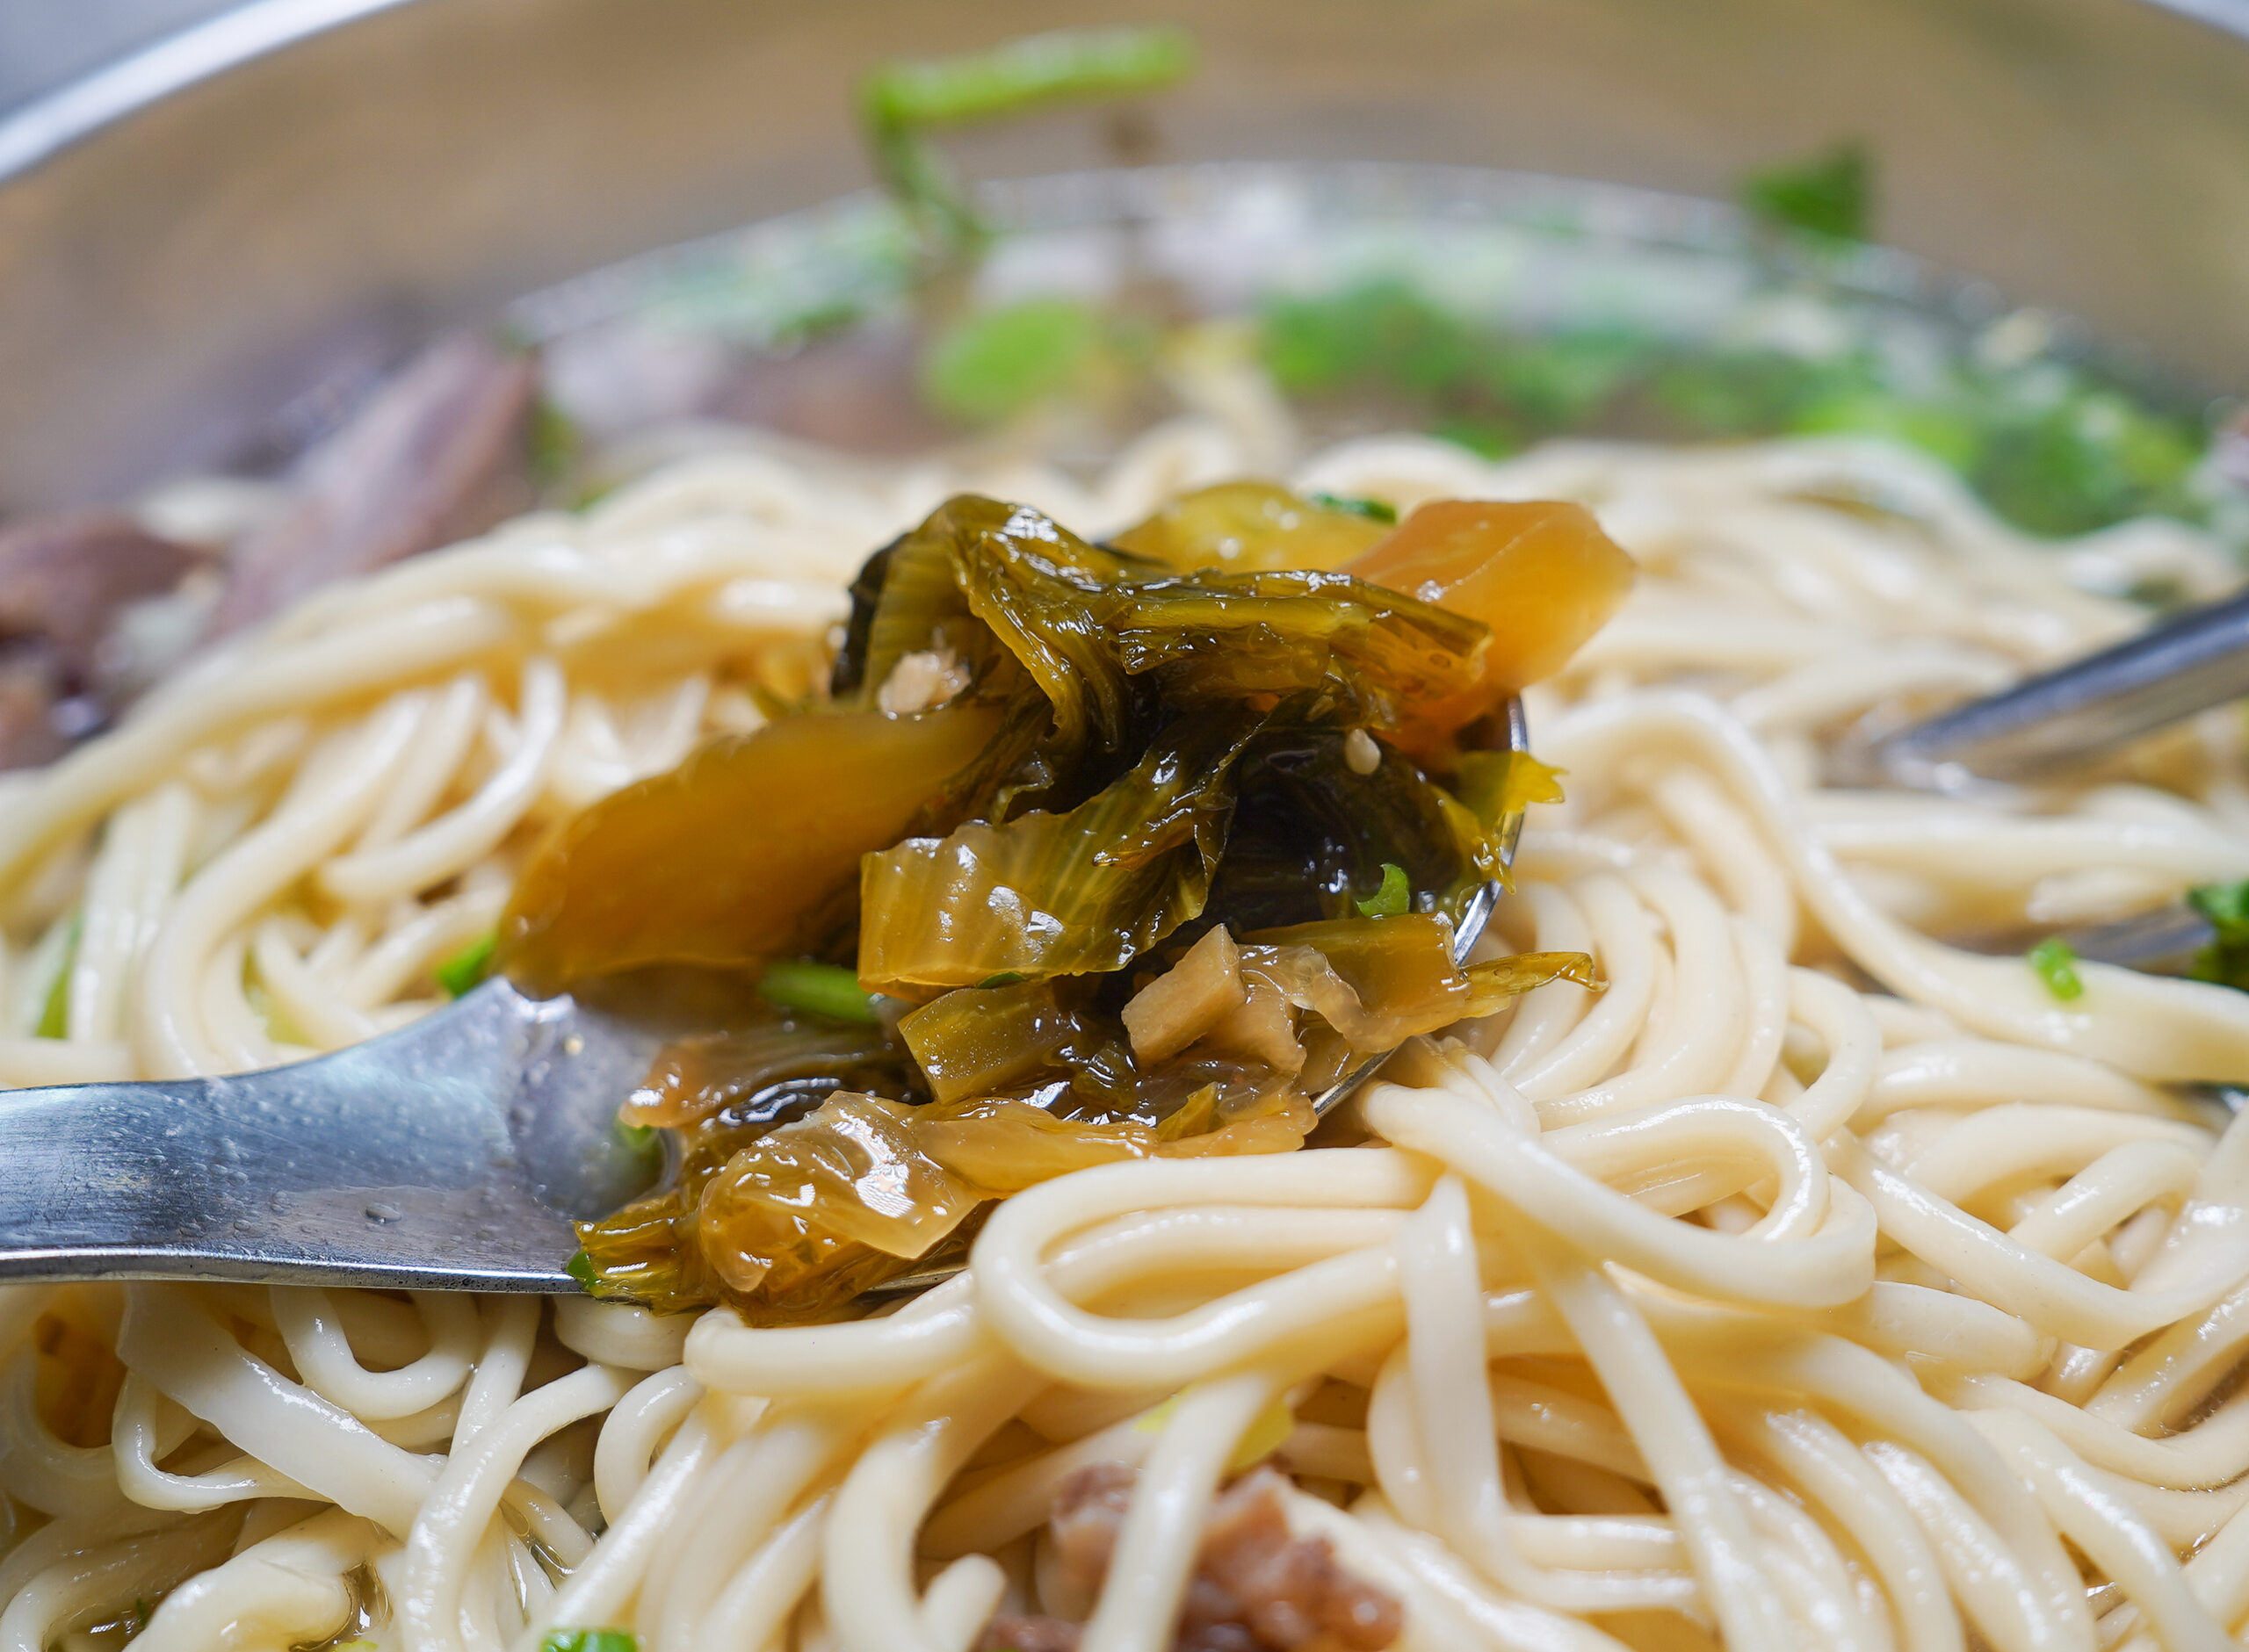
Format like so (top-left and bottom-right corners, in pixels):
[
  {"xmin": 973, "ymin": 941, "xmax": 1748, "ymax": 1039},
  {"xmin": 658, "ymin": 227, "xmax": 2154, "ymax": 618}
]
[{"xmin": 0, "ymin": 701, "xmax": 1527, "ymax": 1293}]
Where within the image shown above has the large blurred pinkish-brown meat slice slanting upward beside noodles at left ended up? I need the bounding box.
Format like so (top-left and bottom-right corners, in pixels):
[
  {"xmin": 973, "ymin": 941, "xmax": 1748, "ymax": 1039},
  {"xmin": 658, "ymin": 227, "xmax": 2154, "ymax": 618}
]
[{"xmin": 213, "ymin": 333, "xmax": 538, "ymax": 631}]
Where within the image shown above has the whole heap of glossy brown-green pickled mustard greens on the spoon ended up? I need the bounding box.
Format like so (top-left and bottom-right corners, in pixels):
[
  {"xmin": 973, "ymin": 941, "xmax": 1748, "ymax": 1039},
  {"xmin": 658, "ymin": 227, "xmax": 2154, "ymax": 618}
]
[{"xmin": 544, "ymin": 486, "xmax": 1628, "ymax": 1322}]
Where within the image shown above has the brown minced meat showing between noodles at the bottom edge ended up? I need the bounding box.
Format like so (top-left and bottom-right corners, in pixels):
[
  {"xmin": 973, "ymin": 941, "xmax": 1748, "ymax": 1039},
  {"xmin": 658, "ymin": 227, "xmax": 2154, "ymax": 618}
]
[{"xmin": 983, "ymin": 1463, "xmax": 1406, "ymax": 1652}]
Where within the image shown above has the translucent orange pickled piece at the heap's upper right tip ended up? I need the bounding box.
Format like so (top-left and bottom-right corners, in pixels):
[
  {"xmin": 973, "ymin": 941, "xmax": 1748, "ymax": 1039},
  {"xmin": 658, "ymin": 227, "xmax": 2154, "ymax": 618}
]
[{"xmin": 1342, "ymin": 499, "xmax": 1635, "ymax": 731}]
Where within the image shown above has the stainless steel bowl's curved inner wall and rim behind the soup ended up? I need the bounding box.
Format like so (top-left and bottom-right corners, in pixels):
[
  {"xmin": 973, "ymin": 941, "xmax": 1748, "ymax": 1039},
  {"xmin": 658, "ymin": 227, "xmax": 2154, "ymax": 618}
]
[{"xmin": 0, "ymin": 0, "xmax": 2249, "ymax": 508}]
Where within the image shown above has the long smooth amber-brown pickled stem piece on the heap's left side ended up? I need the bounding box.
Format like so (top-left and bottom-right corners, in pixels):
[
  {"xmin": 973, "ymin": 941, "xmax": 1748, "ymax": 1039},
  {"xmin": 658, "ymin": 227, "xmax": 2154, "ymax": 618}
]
[{"xmin": 515, "ymin": 706, "xmax": 1001, "ymax": 993}]
